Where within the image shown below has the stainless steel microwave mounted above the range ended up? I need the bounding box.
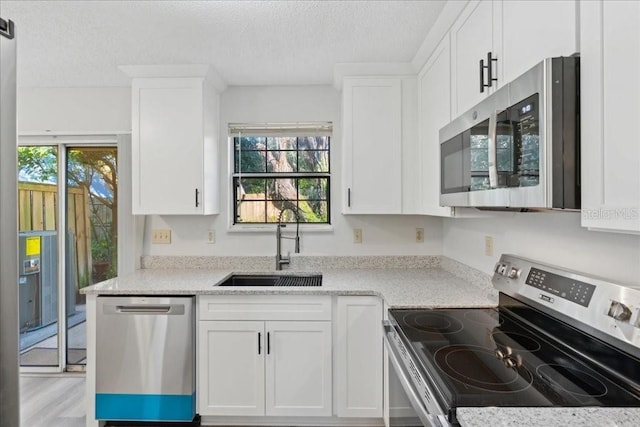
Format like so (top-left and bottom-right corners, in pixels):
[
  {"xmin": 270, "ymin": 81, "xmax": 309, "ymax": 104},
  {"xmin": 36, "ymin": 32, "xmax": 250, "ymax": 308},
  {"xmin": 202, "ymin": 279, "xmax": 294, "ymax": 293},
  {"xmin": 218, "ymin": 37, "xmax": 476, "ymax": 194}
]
[{"xmin": 440, "ymin": 57, "xmax": 580, "ymax": 210}]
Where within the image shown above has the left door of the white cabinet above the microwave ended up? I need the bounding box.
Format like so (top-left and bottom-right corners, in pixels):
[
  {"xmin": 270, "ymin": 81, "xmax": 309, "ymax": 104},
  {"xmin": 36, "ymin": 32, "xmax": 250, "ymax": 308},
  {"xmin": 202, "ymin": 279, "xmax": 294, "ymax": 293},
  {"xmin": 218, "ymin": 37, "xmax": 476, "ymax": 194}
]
[{"xmin": 451, "ymin": 0, "xmax": 502, "ymax": 117}]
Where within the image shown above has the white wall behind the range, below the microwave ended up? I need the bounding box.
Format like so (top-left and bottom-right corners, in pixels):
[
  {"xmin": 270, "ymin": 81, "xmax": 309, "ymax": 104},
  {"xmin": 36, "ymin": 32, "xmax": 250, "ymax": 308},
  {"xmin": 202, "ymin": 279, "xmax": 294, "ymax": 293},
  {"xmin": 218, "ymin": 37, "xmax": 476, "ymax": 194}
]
[{"xmin": 443, "ymin": 212, "xmax": 640, "ymax": 285}]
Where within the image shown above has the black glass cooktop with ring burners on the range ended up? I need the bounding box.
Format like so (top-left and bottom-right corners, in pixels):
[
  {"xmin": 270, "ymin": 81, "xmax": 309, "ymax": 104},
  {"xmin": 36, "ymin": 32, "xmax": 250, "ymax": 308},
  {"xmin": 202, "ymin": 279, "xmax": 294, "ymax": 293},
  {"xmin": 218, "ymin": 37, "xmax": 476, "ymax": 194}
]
[{"xmin": 389, "ymin": 295, "xmax": 640, "ymax": 411}]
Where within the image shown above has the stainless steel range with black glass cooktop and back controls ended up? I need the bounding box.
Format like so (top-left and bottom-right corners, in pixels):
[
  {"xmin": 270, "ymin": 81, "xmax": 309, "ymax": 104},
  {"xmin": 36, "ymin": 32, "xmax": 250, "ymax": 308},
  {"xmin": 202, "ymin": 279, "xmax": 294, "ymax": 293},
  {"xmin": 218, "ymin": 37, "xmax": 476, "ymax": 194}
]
[{"xmin": 384, "ymin": 255, "xmax": 640, "ymax": 426}]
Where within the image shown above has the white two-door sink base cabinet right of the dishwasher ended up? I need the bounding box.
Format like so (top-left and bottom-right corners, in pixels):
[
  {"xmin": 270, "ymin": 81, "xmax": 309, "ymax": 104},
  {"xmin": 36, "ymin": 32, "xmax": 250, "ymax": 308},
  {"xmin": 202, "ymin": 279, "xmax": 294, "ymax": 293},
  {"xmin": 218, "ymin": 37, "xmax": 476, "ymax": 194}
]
[{"xmin": 197, "ymin": 295, "xmax": 332, "ymax": 417}]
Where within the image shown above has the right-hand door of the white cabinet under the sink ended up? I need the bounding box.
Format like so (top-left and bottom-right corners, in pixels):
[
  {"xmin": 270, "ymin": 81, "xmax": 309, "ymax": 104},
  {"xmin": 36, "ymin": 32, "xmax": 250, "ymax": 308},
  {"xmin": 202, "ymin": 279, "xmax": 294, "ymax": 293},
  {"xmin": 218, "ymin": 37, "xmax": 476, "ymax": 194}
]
[{"xmin": 265, "ymin": 321, "xmax": 332, "ymax": 416}]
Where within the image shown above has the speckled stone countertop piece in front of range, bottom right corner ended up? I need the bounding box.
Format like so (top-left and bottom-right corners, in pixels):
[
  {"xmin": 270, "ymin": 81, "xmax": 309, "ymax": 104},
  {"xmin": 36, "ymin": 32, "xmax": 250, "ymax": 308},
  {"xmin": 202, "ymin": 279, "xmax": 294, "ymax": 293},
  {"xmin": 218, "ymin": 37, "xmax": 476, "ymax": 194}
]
[{"xmin": 456, "ymin": 407, "xmax": 640, "ymax": 427}]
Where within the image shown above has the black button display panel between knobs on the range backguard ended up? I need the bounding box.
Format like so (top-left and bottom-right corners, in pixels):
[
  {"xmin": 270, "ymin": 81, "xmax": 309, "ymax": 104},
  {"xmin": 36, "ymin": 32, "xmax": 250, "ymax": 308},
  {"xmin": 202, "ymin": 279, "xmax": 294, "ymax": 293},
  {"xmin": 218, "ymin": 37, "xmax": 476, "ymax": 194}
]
[{"xmin": 525, "ymin": 267, "xmax": 596, "ymax": 307}]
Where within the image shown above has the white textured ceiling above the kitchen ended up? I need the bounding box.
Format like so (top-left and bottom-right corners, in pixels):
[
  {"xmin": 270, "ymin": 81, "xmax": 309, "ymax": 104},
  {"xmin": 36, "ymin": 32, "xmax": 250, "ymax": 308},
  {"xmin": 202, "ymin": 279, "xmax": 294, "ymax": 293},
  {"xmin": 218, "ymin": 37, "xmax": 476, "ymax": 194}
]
[{"xmin": 0, "ymin": 0, "xmax": 445, "ymax": 87}]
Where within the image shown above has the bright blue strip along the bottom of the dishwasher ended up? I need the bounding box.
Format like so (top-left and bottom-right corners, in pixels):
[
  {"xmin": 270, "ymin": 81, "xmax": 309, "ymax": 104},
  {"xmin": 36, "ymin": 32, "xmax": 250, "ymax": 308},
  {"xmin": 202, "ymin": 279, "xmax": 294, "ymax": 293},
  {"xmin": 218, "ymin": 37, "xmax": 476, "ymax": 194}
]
[{"xmin": 96, "ymin": 392, "xmax": 196, "ymax": 421}]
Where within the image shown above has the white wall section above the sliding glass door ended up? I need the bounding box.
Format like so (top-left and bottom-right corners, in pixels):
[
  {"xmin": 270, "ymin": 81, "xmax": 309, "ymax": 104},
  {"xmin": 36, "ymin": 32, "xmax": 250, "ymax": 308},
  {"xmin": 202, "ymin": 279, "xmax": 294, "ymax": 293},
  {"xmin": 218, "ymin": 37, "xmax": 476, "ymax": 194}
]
[{"xmin": 18, "ymin": 87, "xmax": 131, "ymax": 134}]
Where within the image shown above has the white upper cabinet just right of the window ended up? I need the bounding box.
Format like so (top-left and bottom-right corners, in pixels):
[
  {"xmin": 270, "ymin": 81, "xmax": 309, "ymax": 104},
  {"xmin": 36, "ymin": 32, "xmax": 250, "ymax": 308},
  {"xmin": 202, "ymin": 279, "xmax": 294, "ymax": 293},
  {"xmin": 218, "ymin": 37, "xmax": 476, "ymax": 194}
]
[{"xmin": 342, "ymin": 75, "xmax": 421, "ymax": 214}]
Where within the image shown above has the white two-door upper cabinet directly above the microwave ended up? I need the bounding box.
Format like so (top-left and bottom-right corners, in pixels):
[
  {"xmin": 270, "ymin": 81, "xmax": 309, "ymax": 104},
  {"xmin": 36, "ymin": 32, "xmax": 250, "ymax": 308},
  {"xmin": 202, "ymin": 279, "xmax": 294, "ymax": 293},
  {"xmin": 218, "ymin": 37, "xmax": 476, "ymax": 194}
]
[{"xmin": 450, "ymin": 0, "xmax": 577, "ymax": 118}]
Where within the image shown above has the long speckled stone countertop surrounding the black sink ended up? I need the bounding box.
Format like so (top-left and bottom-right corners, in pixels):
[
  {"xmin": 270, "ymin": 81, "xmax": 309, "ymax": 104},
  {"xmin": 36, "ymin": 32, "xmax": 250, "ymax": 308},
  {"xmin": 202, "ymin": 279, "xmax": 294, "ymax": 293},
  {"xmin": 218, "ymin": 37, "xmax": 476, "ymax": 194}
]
[{"xmin": 82, "ymin": 267, "xmax": 497, "ymax": 308}]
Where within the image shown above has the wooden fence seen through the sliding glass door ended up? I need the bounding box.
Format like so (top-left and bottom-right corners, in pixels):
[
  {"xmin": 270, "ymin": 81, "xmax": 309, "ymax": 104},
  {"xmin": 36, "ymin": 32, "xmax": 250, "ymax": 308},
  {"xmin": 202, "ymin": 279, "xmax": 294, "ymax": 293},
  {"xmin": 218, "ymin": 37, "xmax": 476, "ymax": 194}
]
[{"xmin": 18, "ymin": 182, "xmax": 91, "ymax": 286}]
